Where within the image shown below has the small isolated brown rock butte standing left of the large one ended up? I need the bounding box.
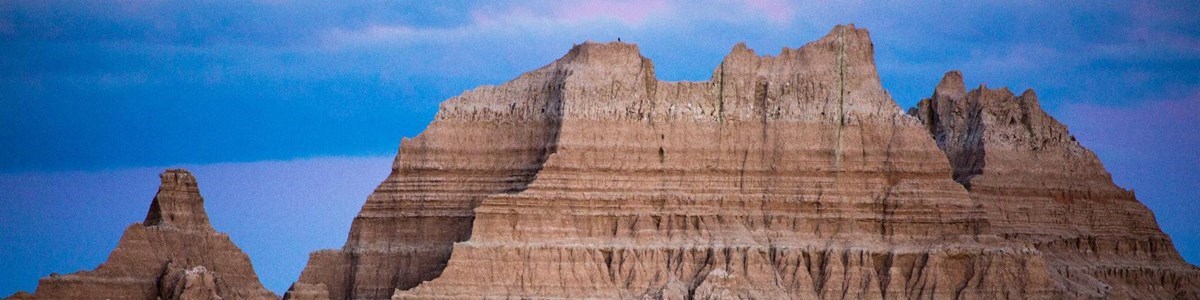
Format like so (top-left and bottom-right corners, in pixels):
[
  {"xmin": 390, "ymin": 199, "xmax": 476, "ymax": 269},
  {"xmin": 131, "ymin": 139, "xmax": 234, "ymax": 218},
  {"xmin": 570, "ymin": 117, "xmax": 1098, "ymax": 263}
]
[{"xmin": 14, "ymin": 169, "xmax": 276, "ymax": 300}]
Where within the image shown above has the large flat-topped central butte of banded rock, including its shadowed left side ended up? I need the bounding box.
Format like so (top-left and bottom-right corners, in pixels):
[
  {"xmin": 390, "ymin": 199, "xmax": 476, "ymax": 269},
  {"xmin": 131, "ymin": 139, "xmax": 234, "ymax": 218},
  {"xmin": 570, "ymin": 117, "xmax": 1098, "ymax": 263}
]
[{"xmin": 300, "ymin": 25, "xmax": 1084, "ymax": 299}]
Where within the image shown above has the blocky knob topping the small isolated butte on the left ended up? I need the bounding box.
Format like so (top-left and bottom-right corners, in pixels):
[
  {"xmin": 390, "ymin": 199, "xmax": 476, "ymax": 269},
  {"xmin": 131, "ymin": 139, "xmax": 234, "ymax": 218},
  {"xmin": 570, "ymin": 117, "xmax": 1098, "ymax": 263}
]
[{"xmin": 142, "ymin": 169, "xmax": 212, "ymax": 230}]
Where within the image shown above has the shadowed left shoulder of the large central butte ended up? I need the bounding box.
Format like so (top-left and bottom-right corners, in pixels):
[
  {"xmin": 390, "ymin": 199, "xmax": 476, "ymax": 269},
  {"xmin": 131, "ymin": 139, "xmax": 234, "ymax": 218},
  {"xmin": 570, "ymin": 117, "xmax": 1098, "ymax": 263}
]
[{"xmin": 292, "ymin": 39, "xmax": 568, "ymax": 299}]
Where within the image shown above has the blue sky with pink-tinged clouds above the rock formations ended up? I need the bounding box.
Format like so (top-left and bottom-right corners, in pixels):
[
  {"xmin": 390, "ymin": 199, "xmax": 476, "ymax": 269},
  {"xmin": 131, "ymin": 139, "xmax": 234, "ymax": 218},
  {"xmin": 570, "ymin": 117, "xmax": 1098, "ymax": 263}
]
[{"xmin": 0, "ymin": 0, "xmax": 1200, "ymax": 295}]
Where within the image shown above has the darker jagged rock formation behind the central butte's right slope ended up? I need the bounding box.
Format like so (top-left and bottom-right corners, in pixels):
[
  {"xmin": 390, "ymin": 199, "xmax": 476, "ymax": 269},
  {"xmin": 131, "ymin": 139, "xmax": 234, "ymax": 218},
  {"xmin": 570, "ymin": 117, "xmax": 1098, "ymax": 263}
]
[{"xmin": 912, "ymin": 71, "xmax": 1200, "ymax": 299}]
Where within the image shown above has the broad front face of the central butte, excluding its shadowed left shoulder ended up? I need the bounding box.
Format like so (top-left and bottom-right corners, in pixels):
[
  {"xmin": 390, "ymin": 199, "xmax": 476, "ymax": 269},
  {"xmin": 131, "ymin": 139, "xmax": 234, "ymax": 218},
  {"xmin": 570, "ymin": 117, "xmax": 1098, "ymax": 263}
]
[{"xmin": 395, "ymin": 26, "xmax": 1052, "ymax": 299}]
